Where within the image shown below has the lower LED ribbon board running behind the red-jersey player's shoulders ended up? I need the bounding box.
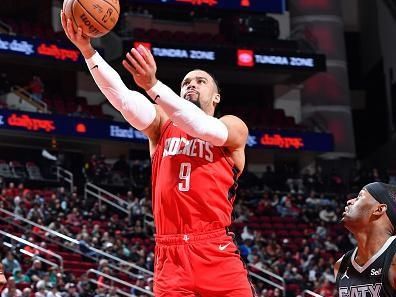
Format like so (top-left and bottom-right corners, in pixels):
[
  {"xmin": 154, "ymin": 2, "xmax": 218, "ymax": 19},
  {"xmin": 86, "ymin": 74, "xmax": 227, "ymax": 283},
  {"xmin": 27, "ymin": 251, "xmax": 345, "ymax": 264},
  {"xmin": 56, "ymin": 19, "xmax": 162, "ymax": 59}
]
[{"xmin": 0, "ymin": 109, "xmax": 334, "ymax": 152}]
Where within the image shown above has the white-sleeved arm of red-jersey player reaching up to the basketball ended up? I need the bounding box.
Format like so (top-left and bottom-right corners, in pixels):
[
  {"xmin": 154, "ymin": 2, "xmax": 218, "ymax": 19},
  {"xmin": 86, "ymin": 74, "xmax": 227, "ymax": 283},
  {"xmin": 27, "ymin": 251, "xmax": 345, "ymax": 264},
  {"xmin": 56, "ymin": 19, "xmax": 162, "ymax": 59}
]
[{"xmin": 61, "ymin": 12, "xmax": 161, "ymax": 137}]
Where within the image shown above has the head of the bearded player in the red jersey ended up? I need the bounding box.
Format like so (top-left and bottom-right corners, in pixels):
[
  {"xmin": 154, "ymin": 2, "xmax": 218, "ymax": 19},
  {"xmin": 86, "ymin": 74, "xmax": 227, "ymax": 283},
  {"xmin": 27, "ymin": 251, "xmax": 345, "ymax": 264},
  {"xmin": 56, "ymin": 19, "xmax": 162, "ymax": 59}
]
[{"xmin": 180, "ymin": 69, "xmax": 220, "ymax": 115}]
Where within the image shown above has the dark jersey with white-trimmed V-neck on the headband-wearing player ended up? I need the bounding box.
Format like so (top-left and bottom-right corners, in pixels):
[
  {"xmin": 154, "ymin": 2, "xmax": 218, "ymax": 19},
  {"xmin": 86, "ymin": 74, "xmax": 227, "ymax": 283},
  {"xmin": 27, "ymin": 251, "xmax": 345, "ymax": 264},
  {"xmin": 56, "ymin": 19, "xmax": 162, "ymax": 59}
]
[{"xmin": 337, "ymin": 236, "xmax": 396, "ymax": 297}]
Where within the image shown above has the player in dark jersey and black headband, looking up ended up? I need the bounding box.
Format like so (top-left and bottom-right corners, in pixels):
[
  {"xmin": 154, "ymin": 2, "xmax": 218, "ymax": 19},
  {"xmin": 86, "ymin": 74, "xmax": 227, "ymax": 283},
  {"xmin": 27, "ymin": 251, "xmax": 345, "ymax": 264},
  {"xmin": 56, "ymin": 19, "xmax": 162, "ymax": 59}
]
[{"xmin": 334, "ymin": 182, "xmax": 396, "ymax": 297}]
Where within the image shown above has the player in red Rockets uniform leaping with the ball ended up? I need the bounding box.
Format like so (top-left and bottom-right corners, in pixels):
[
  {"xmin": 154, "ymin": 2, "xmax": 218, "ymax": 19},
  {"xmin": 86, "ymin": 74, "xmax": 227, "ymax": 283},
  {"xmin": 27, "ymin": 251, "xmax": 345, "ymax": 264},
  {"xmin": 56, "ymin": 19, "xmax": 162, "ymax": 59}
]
[{"xmin": 61, "ymin": 10, "xmax": 255, "ymax": 297}]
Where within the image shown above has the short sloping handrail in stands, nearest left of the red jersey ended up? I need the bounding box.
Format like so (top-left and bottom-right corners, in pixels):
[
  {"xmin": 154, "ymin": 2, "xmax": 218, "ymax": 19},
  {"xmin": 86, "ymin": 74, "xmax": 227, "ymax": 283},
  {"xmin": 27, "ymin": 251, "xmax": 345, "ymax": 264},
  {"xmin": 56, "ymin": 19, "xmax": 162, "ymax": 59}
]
[{"xmin": 84, "ymin": 183, "xmax": 129, "ymax": 214}]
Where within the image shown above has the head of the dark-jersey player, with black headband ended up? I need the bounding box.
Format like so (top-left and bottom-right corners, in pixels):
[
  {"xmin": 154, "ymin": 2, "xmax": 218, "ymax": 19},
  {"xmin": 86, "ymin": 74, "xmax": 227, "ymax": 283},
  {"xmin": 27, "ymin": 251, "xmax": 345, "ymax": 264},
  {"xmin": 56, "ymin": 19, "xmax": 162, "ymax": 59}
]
[{"xmin": 342, "ymin": 182, "xmax": 396, "ymax": 234}]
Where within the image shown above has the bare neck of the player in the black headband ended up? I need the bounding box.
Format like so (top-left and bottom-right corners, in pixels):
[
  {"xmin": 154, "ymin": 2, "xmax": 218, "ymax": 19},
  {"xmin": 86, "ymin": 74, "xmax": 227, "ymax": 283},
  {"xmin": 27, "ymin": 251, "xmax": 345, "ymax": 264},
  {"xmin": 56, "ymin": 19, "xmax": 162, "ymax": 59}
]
[{"xmin": 354, "ymin": 228, "xmax": 391, "ymax": 265}]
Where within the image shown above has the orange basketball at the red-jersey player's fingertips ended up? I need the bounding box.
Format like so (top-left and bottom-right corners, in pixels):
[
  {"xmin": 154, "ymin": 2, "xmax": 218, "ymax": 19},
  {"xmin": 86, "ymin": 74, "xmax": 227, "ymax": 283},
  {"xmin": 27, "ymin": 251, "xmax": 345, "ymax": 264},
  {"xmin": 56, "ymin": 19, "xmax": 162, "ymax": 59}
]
[{"xmin": 63, "ymin": 0, "xmax": 120, "ymax": 38}]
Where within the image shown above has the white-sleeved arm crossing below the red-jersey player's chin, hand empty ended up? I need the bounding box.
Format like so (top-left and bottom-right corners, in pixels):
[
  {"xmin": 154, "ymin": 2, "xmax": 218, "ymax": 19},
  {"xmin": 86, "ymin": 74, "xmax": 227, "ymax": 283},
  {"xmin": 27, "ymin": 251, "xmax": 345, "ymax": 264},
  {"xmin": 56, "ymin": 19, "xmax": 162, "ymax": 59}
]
[{"xmin": 123, "ymin": 46, "xmax": 248, "ymax": 148}]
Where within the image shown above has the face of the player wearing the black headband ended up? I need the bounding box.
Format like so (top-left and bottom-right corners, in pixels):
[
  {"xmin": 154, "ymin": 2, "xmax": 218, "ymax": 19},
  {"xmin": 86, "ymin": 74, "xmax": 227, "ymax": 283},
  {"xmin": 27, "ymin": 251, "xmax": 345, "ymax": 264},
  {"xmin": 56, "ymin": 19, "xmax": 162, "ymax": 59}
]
[{"xmin": 342, "ymin": 189, "xmax": 379, "ymax": 228}]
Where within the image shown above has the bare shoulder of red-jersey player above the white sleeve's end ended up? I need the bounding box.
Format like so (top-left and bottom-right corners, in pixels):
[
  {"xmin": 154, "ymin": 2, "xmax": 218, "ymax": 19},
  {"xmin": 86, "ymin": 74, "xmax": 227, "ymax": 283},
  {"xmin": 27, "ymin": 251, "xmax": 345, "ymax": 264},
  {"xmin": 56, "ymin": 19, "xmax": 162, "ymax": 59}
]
[{"xmin": 220, "ymin": 115, "xmax": 249, "ymax": 149}]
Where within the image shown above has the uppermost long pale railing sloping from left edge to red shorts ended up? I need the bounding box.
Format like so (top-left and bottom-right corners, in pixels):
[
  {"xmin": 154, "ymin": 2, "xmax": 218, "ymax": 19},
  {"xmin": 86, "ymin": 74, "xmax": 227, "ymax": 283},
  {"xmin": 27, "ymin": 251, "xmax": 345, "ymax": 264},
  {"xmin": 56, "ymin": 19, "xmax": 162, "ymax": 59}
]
[{"xmin": 0, "ymin": 208, "xmax": 154, "ymax": 279}]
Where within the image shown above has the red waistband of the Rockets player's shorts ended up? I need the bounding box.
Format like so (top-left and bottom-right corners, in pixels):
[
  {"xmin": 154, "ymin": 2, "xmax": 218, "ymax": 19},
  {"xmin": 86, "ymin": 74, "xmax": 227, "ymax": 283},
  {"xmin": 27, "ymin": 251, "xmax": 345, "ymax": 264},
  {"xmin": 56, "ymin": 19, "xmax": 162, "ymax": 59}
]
[{"xmin": 155, "ymin": 228, "xmax": 228, "ymax": 245}]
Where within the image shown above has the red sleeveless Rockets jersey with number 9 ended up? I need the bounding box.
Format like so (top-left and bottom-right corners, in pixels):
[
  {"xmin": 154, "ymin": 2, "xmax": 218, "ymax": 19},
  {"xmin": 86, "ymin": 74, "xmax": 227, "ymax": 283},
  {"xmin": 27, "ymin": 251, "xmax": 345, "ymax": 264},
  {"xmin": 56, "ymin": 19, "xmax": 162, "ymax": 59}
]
[{"xmin": 152, "ymin": 120, "xmax": 238, "ymax": 235}]
